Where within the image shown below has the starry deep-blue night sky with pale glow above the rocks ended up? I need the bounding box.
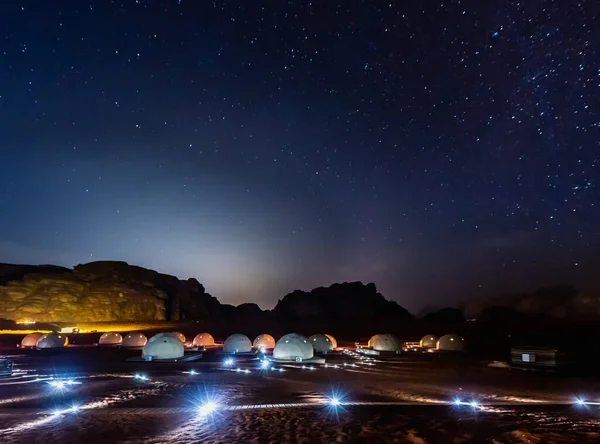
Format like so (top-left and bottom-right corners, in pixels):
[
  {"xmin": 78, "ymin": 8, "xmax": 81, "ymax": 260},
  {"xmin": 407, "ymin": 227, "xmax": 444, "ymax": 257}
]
[{"xmin": 0, "ymin": 0, "xmax": 600, "ymax": 311}]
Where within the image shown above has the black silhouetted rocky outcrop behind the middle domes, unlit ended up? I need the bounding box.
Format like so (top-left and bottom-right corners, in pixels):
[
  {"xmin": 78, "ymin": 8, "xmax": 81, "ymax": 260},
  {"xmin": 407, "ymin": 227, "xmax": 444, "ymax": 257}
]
[{"xmin": 273, "ymin": 282, "xmax": 412, "ymax": 322}]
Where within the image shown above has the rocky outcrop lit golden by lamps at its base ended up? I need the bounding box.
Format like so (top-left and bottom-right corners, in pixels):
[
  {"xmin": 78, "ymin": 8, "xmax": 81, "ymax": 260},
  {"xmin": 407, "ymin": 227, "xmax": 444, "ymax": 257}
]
[{"xmin": 0, "ymin": 261, "xmax": 220, "ymax": 322}]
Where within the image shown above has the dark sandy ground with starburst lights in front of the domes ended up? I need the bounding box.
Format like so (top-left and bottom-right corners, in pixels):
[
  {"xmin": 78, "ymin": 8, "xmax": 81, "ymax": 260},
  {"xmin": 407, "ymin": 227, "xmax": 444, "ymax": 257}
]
[{"xmin": 0, "ymin": 348, "xmax": 600, "ymax": 444}]
